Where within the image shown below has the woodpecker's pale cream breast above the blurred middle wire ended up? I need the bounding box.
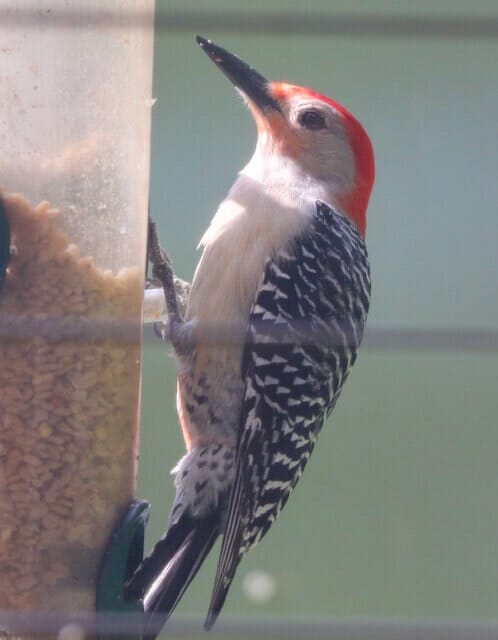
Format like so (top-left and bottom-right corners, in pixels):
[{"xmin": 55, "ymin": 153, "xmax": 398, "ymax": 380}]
[{"xmin": 187, "ymin": 174, "xmax": 320, "ymax": 323}]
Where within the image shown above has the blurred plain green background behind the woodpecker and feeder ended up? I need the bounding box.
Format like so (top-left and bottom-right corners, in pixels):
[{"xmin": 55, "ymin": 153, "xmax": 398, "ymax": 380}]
[{"xmin": 139, "ymin": 0, "xmax": 498, "ymax": 632}]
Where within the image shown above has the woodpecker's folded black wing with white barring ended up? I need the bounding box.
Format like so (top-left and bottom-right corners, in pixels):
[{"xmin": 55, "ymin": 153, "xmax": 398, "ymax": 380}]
[{"xmin": 208, "ymin": 202, "xmax": 370, "ymax": 626}]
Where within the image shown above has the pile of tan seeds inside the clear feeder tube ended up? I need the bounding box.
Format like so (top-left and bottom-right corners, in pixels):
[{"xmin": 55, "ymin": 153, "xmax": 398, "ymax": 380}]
[{"xmin": 0, "ymin": 194, "xmax": 143, "ymax": 610}]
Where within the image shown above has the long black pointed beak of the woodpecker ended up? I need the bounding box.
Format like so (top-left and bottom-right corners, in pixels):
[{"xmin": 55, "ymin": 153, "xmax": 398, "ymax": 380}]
[{"xmin": 196, "ymin": 36, "xmax": 281, "ymax": 111}]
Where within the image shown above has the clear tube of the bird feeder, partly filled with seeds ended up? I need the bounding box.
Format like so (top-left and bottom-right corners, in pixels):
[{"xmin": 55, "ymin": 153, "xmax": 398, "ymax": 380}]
[{"xmin": 0, "ymin": 0, "xmax": 154, "ymax": 611}]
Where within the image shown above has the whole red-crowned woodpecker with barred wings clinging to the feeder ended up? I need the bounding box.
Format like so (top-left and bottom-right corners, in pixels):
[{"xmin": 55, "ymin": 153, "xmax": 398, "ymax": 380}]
[{"xmin": 126, "ymin": 37, "xmax": 374, "ymax": 628}]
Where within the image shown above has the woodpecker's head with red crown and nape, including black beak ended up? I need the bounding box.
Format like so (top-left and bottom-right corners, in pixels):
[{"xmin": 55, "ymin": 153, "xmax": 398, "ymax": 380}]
[{"xmin": 197, "ymin": 36, "xmax": 375, "ymax": 235}]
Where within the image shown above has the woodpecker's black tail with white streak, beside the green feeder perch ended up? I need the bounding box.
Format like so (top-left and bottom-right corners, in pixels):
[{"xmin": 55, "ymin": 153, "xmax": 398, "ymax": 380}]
[{"xmin": 125, "ymin": 515, "xmax": 219, "ymax": 637}]
